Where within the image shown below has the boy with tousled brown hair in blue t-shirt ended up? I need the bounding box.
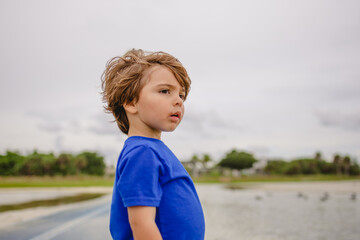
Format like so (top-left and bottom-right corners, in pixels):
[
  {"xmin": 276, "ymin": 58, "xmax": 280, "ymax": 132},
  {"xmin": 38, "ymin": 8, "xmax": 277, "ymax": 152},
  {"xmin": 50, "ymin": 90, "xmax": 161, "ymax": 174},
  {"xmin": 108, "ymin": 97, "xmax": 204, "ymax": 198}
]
[{"xmin": 102, "ymin": 49, "xmax": 205, "ymax": 240}]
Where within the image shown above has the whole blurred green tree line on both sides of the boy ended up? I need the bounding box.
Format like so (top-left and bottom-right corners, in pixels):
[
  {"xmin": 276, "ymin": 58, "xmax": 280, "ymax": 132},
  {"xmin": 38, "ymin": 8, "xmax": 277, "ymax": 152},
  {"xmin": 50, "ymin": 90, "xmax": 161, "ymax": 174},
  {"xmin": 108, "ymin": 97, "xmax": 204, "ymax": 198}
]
[{"xmin": 0, "ymin": 149, "xmax": 360, "ymax": 177}]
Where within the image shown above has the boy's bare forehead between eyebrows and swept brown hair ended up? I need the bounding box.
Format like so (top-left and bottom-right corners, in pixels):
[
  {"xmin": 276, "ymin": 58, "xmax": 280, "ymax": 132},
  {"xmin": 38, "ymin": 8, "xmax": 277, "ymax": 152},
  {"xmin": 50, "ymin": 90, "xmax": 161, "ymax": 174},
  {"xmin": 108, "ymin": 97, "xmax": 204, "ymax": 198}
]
[{"xmin": 144, "ymin": 65, "xmax": 184, "ymax": 89}]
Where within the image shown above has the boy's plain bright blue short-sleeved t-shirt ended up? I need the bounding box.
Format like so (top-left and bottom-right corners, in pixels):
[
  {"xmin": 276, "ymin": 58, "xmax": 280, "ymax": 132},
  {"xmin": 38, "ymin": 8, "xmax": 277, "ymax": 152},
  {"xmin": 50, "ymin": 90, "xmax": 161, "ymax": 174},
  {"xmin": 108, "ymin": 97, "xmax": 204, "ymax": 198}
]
[{"xmin": 110, "ymin": 136, "xmax": 205, "ymax": 240}]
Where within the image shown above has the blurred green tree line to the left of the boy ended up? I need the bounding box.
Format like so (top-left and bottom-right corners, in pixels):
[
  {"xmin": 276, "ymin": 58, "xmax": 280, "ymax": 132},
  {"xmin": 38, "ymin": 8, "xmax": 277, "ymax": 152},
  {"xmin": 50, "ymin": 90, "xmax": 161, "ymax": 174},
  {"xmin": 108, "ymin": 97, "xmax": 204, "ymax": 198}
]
[{"xmin": 0, "ymin": 150, "xmax": 106, "ymax": 176}]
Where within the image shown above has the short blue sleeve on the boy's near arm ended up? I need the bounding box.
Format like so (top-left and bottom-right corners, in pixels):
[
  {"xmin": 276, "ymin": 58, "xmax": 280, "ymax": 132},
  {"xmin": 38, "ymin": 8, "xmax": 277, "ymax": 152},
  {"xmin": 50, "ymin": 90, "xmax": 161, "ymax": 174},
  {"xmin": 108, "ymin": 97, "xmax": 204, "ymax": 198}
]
[{"xmin": 116, "ymin": 146, "xmax": 162, "ymax": 207}]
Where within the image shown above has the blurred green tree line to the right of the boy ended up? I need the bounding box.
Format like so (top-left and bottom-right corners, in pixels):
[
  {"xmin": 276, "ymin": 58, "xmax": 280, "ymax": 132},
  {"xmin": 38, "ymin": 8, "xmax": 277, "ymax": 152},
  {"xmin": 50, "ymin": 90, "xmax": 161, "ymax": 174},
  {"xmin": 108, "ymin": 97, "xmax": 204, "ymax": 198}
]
[{"xmin": 183, "ymin": 149, "xmax": 360, "ymax": 176}]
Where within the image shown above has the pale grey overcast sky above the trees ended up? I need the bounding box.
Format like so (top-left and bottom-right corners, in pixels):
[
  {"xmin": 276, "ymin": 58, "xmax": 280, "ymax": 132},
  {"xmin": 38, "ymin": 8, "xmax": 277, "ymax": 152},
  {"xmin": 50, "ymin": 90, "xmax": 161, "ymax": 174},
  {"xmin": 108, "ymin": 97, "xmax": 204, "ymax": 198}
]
[{"xmin": 0, "ymin": 0, "xmax": 360, "ymax": 163}]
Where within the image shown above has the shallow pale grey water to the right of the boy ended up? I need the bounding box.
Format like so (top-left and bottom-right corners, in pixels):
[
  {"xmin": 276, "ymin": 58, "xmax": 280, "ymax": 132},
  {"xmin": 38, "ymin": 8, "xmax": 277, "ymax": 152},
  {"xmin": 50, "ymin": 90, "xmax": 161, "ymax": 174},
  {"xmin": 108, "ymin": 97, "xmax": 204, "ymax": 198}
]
[{"xmin": 196, "ymin": 184, "xmax": 360, "ymax": 240}]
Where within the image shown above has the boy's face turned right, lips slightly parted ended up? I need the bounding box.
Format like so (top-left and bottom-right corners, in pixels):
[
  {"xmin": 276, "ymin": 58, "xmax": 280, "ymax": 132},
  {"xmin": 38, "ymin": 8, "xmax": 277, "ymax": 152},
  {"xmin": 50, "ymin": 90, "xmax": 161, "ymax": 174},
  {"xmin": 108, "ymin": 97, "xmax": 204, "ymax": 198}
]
[{"xmin": 130, "ymin": 66, "xmax": 185, "ymax": 138}]
